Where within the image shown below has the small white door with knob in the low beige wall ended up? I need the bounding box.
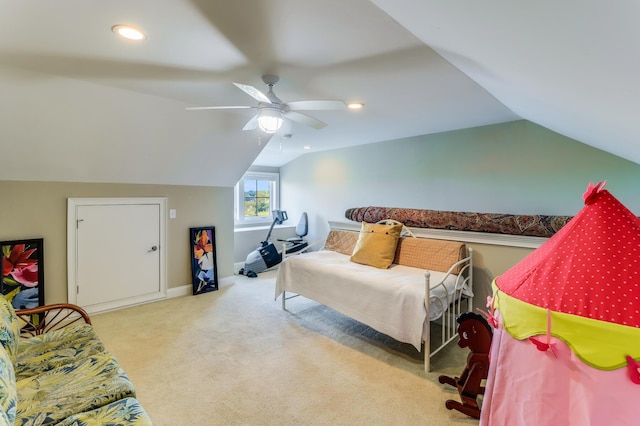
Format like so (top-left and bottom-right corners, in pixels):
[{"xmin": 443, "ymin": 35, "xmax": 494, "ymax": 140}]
[{"xmin": 69, "ymin": 199, "xmax": 166, "ymax": 313}]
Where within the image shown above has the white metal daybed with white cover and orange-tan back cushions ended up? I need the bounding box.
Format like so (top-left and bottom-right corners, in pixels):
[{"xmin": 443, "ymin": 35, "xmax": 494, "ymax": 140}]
[{"xmin": 275, "ymin": 224, "xmax": 473, "ymax": 371}]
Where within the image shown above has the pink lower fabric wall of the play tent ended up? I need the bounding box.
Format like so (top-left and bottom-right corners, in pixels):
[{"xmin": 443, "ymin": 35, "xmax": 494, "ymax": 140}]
[{"xmin": 480, "ymin": 312, "xmax": 640, "ymax": 426}]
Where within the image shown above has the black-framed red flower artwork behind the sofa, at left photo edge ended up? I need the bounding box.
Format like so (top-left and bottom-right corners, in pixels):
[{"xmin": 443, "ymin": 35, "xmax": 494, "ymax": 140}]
[{"xmin": 0, "ymin": 238, "xmax": 44, "ymax": 309}]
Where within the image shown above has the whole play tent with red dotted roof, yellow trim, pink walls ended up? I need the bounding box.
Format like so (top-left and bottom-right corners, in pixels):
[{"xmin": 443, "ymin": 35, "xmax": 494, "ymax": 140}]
[{"xmin": 481, "ymin": 182, "xmax": 640, "ymax": 425}]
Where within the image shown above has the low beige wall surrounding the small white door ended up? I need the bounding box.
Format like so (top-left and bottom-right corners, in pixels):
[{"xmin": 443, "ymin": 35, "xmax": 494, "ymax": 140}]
[{"xmin": 0, "ymin": 181, "xmax": 234, "ymax": 303}]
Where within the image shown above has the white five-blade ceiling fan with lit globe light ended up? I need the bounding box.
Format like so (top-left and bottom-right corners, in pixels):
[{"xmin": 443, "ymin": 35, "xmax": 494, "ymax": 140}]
[{"xmin": 187, "ymin": 74, "xmax": 346, "ymax": 133}]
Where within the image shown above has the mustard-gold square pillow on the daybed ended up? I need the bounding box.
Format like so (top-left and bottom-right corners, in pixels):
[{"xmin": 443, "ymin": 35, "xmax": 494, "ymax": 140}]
[{"xmin": 351, "ymin": 222, "xmax": 402, "ymax": 269}]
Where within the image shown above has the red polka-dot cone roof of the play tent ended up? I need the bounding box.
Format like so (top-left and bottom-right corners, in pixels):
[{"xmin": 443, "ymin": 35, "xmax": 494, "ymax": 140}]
[{"xmin": 496, "ymin": 184, "xmax": 640, "ymax": 327}]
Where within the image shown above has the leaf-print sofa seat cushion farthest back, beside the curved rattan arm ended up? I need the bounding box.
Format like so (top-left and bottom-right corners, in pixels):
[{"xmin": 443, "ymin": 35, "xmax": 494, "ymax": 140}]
[{"xmin": 15, "ymin": 324, "xmax": 106, "ymax": 380}]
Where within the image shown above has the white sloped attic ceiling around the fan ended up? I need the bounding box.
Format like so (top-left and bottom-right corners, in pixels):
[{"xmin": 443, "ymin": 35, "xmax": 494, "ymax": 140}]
[{"xmin": 0, "ymin": 0, "xmax": 640, "ymax": 186}]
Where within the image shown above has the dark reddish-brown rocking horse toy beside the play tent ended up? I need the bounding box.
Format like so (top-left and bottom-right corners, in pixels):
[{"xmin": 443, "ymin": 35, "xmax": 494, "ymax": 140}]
[{"xmin": 438, "ymin": 312, "xmax": 493, "ymax": 419}]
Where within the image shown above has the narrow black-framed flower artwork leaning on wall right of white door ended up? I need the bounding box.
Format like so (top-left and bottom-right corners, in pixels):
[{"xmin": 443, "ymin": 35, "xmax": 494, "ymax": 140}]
[{"xmin": 189, "ymin": 226, "xmax": 218, "ymax": 295}]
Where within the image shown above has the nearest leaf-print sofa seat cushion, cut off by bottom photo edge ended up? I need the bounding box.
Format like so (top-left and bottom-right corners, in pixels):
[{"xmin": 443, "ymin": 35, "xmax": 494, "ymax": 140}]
[{"xmin": 58, "ymin": 398, "xmax": 152, "ymax": 426}]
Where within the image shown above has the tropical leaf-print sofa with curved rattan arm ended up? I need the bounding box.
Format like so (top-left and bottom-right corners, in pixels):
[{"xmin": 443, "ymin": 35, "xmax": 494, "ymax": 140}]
[{"xmin": 0, "ymin": 295, "xmax": 152, "ymax": 426}]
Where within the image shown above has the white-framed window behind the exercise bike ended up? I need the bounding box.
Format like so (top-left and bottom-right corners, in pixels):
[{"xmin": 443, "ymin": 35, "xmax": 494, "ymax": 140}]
[{"xmin": 234, "ymin": 172, "xmax": 279, "ymax": 225}]
